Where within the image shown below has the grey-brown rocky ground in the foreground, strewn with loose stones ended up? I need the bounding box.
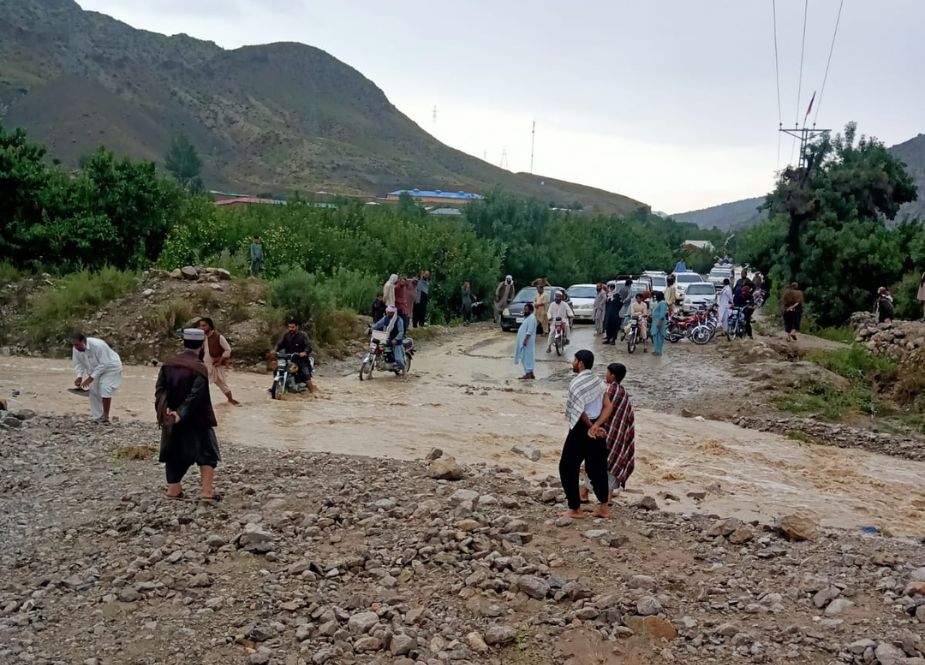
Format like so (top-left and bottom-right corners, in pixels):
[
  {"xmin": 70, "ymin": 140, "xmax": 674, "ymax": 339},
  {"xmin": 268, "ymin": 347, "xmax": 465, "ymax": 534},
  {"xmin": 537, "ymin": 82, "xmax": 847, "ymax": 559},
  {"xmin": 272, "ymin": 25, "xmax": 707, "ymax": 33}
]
[{"xmin": 0, "ymin": 413, "xmax": 925, "ymax": 665}]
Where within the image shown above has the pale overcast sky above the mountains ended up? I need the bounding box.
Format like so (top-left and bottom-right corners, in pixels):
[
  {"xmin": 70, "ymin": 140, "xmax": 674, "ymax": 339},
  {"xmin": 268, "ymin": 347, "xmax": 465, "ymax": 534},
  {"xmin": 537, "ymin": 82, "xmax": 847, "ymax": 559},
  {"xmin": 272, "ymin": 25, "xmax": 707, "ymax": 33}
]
[{"xmin": 78, "ymin": 0, "xmax": 925, "ymax": 213}]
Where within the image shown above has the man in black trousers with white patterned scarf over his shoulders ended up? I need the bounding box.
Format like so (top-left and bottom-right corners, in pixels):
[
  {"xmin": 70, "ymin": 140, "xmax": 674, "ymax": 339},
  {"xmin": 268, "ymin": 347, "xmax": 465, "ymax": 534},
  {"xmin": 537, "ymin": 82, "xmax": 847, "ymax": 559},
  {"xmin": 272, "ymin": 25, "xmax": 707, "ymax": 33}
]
[{"xmin": 559, "ymin": 349, "xmax": 610, "ymax": 519}]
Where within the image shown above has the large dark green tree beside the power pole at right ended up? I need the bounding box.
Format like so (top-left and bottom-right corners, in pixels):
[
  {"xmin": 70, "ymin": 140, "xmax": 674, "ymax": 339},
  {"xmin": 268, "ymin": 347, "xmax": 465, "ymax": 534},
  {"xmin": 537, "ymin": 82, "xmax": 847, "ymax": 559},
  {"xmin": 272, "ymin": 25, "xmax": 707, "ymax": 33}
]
[{"xmin": 735, "ymin": 124, "xmax": 925, "ymax": 326}]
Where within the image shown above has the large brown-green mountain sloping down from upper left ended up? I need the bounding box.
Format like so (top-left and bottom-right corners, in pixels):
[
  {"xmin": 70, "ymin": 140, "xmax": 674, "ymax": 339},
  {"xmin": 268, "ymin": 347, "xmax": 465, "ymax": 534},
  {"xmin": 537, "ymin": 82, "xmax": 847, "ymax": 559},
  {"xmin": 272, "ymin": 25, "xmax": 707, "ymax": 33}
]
[{"xmin": 0, "ymin": 0, "xmax": 644, "ymax": 213}]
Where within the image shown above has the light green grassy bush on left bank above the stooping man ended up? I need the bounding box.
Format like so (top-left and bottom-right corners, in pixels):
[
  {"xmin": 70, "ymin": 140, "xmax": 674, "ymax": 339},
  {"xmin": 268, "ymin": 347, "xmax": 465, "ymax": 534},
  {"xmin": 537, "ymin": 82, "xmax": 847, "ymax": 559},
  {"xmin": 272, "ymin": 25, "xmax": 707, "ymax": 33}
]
[{"xmin": 27, "ymin": 268, "xmax": 137, "ymax": 344}]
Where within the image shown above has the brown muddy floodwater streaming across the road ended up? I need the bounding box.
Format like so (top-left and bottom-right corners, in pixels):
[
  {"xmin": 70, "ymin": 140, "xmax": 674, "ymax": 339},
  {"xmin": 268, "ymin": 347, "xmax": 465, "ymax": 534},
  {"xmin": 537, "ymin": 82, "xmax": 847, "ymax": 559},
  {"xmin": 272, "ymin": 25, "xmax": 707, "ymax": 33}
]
[{"xmin": 0, "ymin": 327, "xmax": 925, "ymax": 536}]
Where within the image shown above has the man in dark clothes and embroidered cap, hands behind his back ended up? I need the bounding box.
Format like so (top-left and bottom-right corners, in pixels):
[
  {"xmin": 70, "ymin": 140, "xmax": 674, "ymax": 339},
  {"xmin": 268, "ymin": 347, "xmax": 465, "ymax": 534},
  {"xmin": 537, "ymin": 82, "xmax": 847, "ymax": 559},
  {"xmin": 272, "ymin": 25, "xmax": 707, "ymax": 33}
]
[{"xmin": 154, "ymin": 328, "xmax": 221, "ymax": 503}]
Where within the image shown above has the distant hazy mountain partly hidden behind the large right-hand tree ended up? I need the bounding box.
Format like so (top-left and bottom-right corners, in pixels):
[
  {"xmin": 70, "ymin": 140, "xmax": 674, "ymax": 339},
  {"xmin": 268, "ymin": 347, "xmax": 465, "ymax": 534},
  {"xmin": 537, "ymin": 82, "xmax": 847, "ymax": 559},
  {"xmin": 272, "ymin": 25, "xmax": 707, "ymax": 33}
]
[{"xmin": 671, "ymin": 134, "xmax": 925, "ymax": 231}]
